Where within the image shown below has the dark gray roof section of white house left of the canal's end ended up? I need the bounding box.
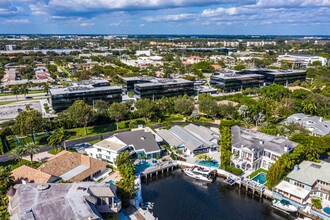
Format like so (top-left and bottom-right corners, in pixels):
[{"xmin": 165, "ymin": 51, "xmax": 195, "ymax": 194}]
[{"xmin": 114, "ymin": 130, "xmax": 160, "ymax": 153}]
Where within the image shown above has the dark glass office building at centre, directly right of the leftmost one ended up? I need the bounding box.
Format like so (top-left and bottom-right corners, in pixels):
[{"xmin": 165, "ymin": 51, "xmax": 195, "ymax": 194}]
[{"xmin": 134, "ymin": 79, "xmax": 195, "ymax": 99}]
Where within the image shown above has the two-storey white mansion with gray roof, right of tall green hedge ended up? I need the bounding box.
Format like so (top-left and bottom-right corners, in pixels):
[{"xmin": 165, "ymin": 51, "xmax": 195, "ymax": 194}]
[{"xmin": 231, "ymin": 126, "xmax": 298, "ymax": 172}]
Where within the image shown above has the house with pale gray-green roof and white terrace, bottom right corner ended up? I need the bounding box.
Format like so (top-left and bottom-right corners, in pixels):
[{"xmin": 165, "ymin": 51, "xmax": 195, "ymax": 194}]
[{"xmin": 273, "ymin": 161, "xmax": 330, "ymax": 219}]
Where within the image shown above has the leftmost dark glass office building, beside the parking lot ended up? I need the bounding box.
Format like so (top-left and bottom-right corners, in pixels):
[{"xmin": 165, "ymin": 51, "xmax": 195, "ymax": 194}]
[{"xmin": 49, "ymin": 85, "xmax": 122, "ymax": 111}]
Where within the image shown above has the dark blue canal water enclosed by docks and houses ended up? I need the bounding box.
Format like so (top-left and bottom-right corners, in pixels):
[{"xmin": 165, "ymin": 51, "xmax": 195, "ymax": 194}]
[{"xmin": 142, "ymin": 170, "xmax": 293, "ymax": 220}]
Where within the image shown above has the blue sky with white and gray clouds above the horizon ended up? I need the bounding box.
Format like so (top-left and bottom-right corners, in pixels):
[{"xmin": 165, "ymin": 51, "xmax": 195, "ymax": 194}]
[{"xmin": 0, "ymin": 0, "xmax": 330, "ymax": 35}]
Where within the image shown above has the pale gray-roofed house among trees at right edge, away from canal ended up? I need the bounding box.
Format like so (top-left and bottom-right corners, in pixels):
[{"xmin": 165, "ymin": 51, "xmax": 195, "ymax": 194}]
[{"xmin": 281, "ymin": 113, "xmax": 330, "ymax": 136}]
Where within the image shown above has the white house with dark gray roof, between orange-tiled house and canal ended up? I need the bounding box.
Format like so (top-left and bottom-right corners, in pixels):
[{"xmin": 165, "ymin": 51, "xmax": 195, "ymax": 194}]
[{"xmin": 86, "ymin": 129, "xmax": 162, "ymax": 165}]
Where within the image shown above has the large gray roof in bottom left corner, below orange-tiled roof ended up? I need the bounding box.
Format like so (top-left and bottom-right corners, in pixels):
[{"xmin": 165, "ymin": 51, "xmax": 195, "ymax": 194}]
[{"xmin": 9, "ymin": 182, "xmax": 115, "ymax": 220}]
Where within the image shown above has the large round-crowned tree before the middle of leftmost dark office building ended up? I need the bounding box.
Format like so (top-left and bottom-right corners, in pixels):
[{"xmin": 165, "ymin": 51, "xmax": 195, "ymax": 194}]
[{"xmin": 67, "ymin": 100, "xmax": 94, "ymax": 135}]
